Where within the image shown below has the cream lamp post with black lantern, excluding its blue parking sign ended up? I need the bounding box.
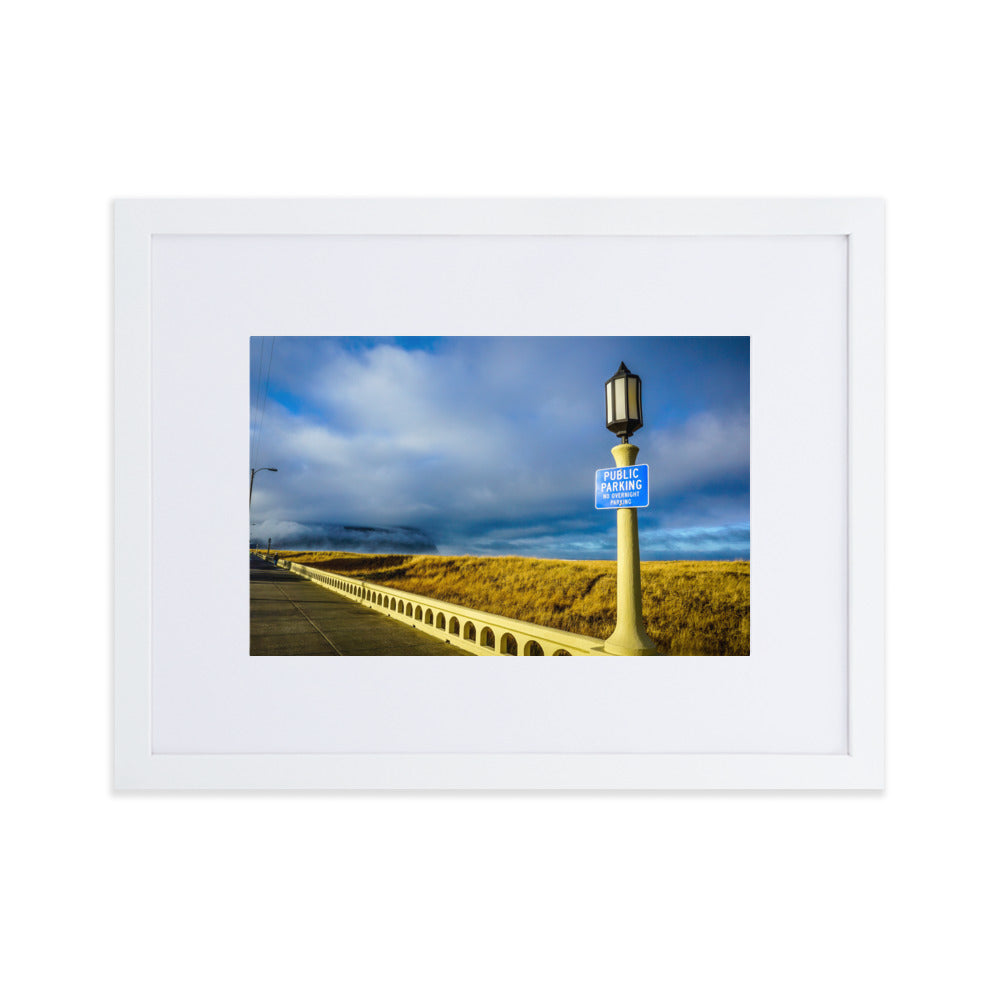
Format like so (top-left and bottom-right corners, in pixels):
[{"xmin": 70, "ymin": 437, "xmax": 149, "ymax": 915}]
[{"xmin": 604, "ymin": 361, "xmax": 656, "ymax": 656}]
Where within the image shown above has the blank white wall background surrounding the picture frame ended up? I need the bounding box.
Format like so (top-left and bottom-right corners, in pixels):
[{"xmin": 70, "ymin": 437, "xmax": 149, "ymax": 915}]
[{"xmin": 0, "ymin": 0, "xmax": 1000, "ymax": 1000}]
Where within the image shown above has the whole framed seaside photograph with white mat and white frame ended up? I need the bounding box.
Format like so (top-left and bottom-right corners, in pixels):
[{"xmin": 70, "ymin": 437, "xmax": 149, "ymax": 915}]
[{"xmin": 115, "ymin": 199, "xmax": 884, "ymax": 790}]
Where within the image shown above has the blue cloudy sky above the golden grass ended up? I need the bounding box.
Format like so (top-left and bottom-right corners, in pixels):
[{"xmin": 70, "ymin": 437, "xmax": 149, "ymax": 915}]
[{"xmin": 250, "ymin": 337, "xmax": 750, "ymax": 560}]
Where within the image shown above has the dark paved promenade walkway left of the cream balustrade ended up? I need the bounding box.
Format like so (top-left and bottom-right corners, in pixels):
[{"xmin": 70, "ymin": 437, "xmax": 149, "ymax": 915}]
[{"xmin": 250, "ymin": 556, "xmax": 472, "ymax": 656}]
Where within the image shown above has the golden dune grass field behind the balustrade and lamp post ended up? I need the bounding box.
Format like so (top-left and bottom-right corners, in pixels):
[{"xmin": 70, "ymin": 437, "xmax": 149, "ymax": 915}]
[{"xmin": 274, "ymin": 551, "xmax": 750, "ymax": 656}]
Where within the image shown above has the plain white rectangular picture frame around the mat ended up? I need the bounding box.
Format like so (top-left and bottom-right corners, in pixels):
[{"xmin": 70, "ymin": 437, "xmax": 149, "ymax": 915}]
[{"xmin": 114, "ymin": 199, "xmax": 885, "ymax": 790}]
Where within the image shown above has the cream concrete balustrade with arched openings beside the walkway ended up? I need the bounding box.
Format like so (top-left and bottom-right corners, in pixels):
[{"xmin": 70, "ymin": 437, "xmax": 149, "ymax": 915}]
[{"xmin": 276, "ymin": 559, "xmax": 608, "ymax": 656}]
